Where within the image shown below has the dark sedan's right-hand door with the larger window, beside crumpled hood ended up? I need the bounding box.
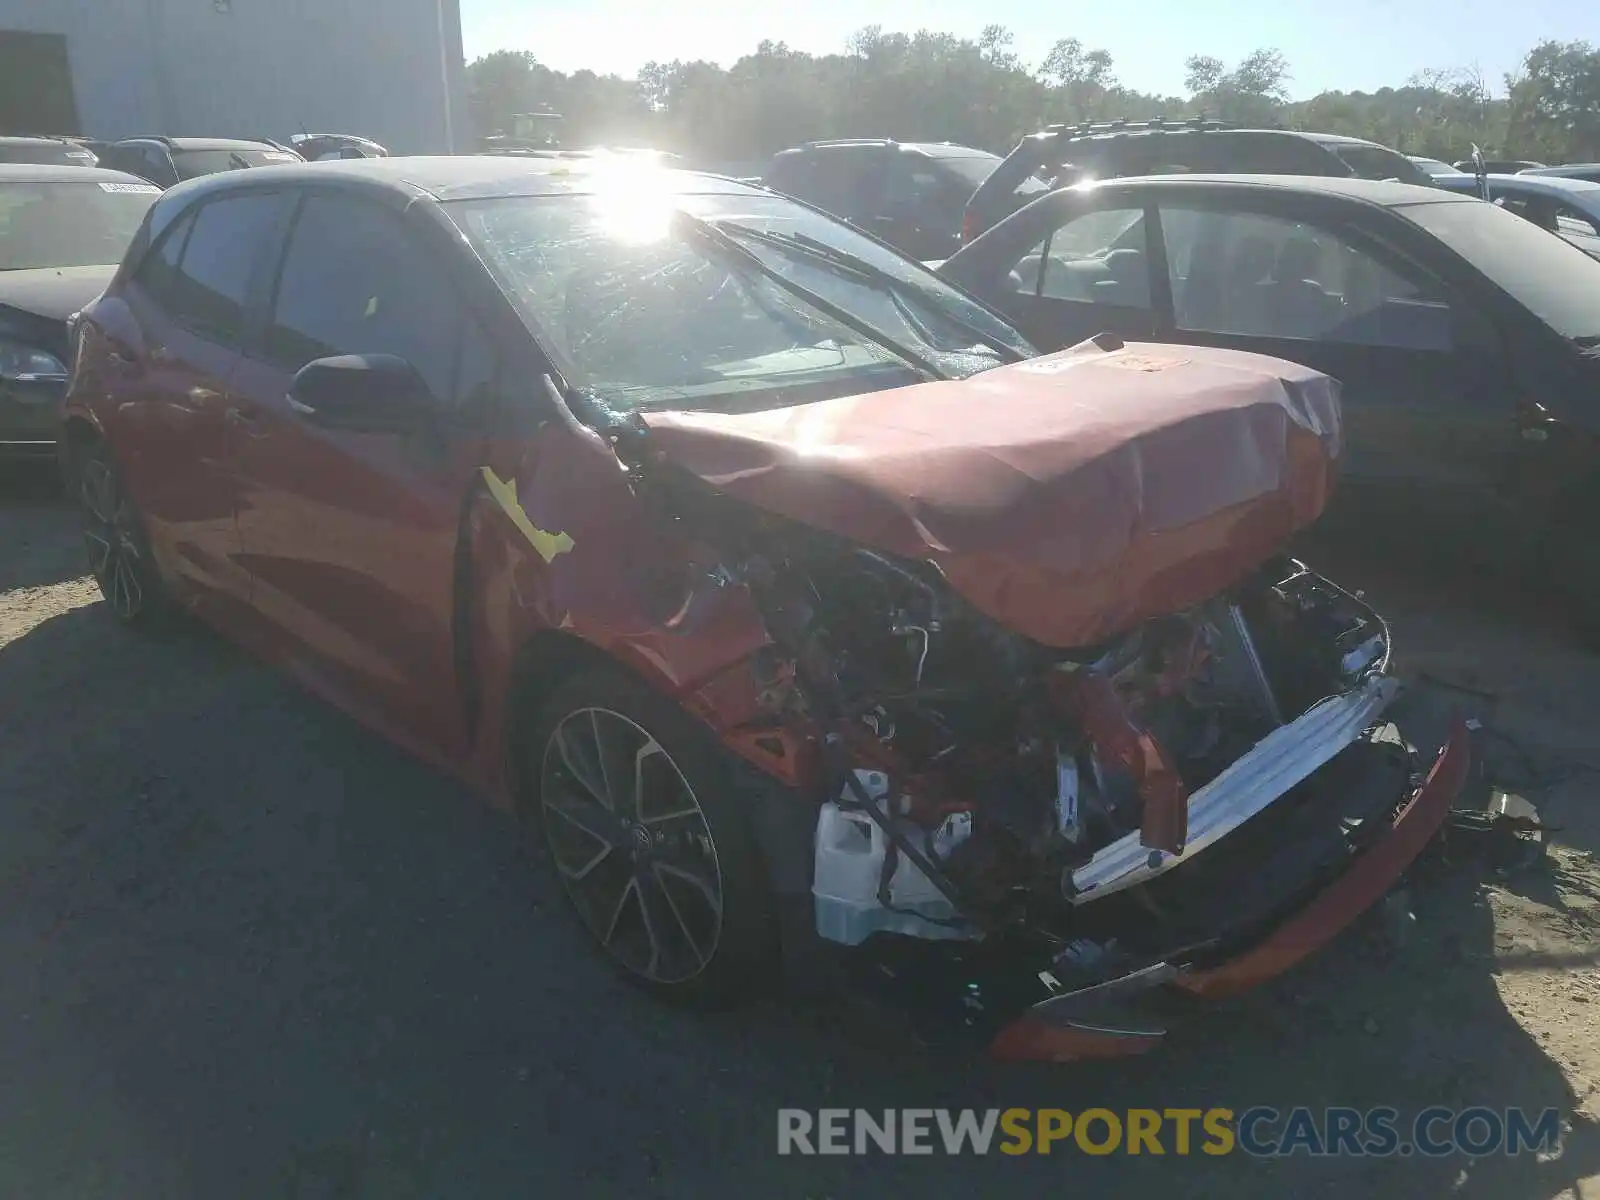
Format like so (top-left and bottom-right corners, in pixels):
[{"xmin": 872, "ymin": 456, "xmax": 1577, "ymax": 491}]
[{"xmin": 1158, "ymin": 200, "xmax": 1520, "ymax": 525}]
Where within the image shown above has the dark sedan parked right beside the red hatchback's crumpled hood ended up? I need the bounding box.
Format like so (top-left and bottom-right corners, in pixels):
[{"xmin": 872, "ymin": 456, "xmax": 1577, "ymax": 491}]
[{"xmin": 939, "ymin": 176, "xmax": 1600, "ymax": 621}]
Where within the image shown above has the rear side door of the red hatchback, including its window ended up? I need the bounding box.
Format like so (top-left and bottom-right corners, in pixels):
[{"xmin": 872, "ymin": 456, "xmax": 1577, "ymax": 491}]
[{"xmin": 109, "ymin": 192, "xmax": 290, "ymax": 600}]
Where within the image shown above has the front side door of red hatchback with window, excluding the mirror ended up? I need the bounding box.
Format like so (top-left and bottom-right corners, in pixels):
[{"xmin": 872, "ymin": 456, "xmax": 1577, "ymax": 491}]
[{"xmin": 234, "ymin": 192, "xmax": 498, "ymax": 758}]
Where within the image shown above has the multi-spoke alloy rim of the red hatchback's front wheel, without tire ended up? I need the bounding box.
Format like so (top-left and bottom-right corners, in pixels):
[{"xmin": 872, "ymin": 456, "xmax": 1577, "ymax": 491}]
[{"xmin": 539, "ymin": 707, "xmax": 723, "ymax": 984}]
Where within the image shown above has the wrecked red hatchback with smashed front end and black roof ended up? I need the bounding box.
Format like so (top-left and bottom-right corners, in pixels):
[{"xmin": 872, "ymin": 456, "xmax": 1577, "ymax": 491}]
[{"xmin": 62, "ymin": 158, "xmax": 1467, "ymax": 1059}]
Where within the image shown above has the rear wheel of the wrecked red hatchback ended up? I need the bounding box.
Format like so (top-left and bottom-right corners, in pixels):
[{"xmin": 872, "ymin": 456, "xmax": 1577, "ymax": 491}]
[{"xmin": 69, "ymin": 442, "xmax": 176, "ymax": 630}]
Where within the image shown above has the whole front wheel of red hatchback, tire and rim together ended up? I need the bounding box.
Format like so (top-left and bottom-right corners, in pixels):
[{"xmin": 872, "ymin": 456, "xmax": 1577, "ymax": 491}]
[{"xmin": 520, "ymin": 669, "xmax": 776, "ymax": 1005}]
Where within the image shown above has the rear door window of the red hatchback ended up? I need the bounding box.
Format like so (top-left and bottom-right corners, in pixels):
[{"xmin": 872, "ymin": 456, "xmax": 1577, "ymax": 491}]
[{"xmin": 168, "ymin": 192, "xmax": 290, "ymax": 346}]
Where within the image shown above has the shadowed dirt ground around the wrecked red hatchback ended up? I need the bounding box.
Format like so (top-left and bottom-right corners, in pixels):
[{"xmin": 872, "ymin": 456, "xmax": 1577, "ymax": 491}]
[{"xmin": 0, "ymin": 464, "xmax": 1600, "ymax": 1200}]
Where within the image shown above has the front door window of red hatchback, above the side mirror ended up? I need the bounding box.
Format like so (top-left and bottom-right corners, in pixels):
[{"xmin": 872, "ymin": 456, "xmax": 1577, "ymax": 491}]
[{"xmin": 266, "ymin": 195, "xmax": 464, "ymax": 400}]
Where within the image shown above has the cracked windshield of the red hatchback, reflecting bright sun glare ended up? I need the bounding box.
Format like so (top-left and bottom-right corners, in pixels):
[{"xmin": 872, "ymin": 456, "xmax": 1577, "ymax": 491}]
[{"xmin": 448, "ymin": 187, "xmax": 1032, "ymax": 411}]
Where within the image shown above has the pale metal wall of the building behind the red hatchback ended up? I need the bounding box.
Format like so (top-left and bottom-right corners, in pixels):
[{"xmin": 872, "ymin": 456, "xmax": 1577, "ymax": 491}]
[{"xmin": 0, "ymin": 0, "xmax": 470, "ymax": 154}]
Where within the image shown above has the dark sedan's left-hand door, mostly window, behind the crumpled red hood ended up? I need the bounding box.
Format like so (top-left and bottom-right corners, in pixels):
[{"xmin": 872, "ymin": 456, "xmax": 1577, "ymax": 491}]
[{"xmin": 939, "ymin": 189, "xmax": 1157, "ymax": 350}]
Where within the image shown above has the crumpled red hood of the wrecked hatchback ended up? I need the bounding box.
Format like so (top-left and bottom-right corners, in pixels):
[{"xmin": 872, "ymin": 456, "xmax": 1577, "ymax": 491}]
[{"xmin": 645, "ymin": 342, "xmax": 1339, "ymax": 646}]
